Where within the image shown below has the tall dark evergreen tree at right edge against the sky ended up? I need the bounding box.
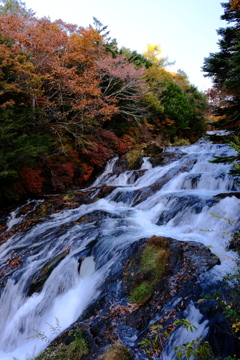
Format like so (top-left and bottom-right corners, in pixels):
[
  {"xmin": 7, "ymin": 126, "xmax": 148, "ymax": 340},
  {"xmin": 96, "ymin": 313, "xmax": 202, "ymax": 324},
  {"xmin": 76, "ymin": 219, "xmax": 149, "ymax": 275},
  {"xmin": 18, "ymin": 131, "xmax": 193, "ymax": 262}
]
[{"xmin": 203, "ymin": 1, "xmax": 240, "ymax": 129}]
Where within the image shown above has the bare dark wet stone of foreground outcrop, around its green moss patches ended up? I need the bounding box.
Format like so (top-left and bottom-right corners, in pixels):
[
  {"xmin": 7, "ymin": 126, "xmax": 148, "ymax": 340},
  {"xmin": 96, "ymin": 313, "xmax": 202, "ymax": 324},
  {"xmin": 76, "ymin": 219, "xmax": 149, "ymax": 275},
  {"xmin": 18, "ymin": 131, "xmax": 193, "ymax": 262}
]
[{"xmin": 54, "ymin": 237, "xmax": 219, "ymax": 360}]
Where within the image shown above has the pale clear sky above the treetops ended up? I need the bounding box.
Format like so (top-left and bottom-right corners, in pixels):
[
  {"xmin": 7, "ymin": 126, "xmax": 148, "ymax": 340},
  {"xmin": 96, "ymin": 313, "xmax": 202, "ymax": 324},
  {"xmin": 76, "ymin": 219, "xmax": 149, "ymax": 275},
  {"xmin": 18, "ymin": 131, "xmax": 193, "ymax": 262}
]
[{"xmin": 24, "ymin": 0, "xmax": 227, "ymax": 91}]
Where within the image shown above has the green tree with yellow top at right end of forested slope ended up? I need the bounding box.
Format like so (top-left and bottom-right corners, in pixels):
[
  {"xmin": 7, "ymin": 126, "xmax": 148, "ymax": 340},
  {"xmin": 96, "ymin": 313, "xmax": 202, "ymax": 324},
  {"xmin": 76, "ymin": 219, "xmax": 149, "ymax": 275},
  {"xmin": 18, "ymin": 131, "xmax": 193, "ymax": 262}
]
[{"xmin": 141, "ymin": 47, "xmax": 206, "ymax": 141}]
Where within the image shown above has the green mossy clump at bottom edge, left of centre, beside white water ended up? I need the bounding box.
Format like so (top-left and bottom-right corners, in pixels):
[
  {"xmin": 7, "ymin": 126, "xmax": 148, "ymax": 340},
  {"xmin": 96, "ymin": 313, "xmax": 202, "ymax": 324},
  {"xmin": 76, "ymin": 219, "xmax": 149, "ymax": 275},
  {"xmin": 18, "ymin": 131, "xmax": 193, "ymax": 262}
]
[{"xmin": 36, "ymin": 331, "xmax": 89, "ymax": 360}]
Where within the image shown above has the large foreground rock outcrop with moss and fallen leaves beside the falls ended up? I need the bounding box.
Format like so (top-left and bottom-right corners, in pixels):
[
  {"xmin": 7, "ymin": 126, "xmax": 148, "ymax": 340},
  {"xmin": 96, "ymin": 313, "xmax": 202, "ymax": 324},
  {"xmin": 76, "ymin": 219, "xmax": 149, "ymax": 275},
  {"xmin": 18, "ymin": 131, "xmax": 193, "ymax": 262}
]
[{"xmin": 45, "ymin": 236, "xmax": 240, "ymax": 360}]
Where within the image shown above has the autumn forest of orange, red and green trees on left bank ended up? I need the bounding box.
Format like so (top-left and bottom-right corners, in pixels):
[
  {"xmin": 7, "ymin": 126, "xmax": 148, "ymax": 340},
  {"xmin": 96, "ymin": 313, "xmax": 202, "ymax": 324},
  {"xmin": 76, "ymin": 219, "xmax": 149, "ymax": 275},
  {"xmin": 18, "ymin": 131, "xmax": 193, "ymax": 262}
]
[{"xmin": 0, "ymin": 0, "xmax": 207, "ymax": 204}]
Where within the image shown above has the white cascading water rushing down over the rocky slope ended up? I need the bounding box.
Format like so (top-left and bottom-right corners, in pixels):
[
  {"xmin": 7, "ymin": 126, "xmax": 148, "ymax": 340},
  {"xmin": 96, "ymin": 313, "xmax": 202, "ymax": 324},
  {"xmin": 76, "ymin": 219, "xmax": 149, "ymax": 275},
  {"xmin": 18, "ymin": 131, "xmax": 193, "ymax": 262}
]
[{"xmin": 0, "ymin": 136, "xmax": 240, "ymax": 360}]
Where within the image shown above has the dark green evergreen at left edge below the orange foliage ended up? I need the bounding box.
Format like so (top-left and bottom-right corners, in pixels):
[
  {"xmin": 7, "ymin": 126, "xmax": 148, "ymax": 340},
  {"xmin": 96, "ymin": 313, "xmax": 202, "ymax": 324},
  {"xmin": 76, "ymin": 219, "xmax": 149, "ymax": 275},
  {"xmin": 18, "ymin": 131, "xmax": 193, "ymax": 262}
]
[{"xmin": 0, "ymin": 105, "xmax": 53, "ymax": 201}]
